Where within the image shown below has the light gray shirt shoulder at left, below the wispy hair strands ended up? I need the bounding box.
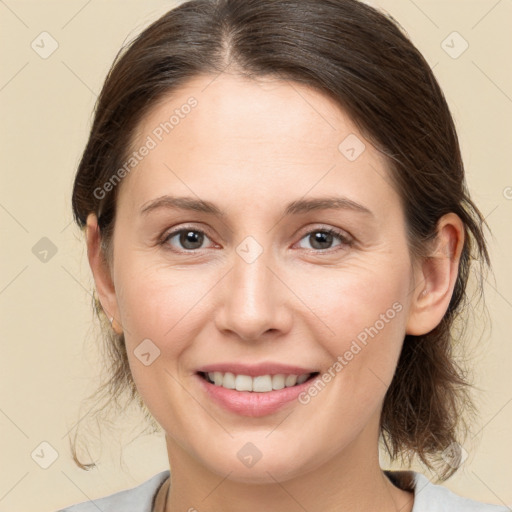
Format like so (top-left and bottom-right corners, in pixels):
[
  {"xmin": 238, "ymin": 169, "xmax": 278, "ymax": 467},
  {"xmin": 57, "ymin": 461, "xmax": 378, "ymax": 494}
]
[{"xmin": 58, "ymin": 470, "xmax": 170, "ymax": 512}]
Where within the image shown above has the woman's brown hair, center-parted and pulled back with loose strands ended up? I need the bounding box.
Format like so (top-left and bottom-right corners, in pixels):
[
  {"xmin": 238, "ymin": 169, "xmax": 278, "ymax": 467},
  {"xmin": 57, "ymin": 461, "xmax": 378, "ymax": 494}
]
[{"xmin": 72, "ymin": 0, "xmax": 490, "ymax": 479}]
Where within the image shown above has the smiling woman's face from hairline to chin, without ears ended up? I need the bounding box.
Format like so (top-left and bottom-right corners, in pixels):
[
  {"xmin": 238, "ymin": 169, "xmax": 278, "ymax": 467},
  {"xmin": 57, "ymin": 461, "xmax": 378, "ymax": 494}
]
[{"xmin": 97, "ymin": 74, "xmax": 424, "ymax": 482}]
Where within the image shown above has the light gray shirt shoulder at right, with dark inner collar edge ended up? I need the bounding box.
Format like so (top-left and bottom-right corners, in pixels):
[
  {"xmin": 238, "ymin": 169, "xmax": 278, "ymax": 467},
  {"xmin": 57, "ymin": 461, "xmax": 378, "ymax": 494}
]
[{"xmin": 386, "ymin": 471, "xmax": 510, "ymax": 512}]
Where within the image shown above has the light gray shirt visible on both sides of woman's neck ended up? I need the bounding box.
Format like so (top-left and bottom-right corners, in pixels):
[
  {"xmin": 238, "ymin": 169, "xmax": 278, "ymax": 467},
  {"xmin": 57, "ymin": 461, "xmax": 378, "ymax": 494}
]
[{"xmin": 58, "ymin": 470, "xmax": 512, "ymax": 512}]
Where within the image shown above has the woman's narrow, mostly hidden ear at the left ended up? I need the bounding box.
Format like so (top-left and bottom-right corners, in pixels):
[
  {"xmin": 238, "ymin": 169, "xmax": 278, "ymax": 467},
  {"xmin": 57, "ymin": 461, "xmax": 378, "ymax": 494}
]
[{"xmin": 86, "ymin": 213, "xmax": 123, "ymax": 334}]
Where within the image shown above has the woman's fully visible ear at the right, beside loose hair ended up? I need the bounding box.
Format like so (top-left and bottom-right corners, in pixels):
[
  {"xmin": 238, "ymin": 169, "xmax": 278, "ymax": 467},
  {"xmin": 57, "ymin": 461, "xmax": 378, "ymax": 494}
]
[{"xmin": 406, "ymin": 212, "xmax": 464, "ymax": 336}]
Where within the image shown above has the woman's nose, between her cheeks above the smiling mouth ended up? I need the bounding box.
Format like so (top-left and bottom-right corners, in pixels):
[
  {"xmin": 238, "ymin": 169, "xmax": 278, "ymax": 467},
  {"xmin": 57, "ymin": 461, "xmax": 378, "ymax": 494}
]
[{"xmin": 215, "ymin": 246, "xmax": 292, "ymax": 341}]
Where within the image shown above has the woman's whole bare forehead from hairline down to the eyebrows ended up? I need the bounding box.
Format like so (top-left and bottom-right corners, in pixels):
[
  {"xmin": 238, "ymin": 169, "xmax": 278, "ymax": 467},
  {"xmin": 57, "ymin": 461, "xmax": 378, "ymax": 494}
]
[{"xmin": 121, "ymin": 74, "xmax": 397, "ymax": 214}]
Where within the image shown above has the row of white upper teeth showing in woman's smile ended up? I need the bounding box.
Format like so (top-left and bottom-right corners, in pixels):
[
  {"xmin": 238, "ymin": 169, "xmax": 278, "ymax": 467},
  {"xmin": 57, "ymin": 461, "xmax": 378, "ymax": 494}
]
[{"xmin": 208, "ymin": 372, "xmax": 312, "ymax": 393}]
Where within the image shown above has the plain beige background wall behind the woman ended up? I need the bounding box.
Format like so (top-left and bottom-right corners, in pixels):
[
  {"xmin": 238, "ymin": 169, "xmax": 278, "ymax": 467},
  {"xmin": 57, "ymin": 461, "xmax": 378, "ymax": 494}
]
[{"xmin": 0, "ymin": 0, "xmax": 512, "ymax": 512}]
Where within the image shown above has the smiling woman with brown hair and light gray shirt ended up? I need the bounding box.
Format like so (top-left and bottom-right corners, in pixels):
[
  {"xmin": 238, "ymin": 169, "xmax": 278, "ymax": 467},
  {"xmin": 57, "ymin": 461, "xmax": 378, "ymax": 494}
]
[{"xmin": 58, "ymin": 0, "xmax": 505, "ymax": 512}]
